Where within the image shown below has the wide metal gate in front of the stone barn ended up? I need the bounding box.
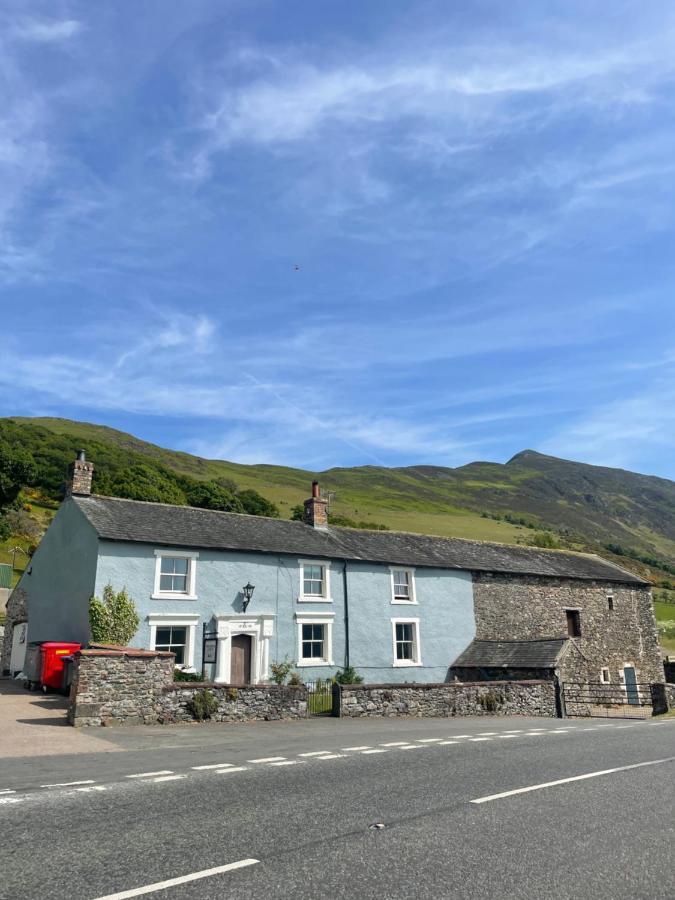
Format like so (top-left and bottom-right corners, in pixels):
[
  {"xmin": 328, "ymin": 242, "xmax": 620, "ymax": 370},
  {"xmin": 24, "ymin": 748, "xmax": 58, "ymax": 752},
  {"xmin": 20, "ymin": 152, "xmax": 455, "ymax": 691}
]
[{"xmin": 562, "ymin": 681, "xmax": 653, "ymax": 719}]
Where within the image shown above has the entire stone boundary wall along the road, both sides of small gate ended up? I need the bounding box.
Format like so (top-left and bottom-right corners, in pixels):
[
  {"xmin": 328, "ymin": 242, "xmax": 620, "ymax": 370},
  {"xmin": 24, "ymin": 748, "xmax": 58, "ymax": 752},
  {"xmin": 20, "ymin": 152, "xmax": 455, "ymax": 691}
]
[{"xmin": 68, "ymin": 647, "xmax": 560, "ymax": 726}]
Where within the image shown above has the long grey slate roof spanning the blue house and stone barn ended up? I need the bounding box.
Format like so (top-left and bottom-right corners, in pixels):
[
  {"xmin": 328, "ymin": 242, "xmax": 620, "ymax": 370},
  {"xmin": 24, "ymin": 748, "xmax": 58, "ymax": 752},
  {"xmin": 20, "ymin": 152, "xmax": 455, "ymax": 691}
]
[{"xmin": 72, "ymin": 495, "xmax": 645, "ymax": 584}]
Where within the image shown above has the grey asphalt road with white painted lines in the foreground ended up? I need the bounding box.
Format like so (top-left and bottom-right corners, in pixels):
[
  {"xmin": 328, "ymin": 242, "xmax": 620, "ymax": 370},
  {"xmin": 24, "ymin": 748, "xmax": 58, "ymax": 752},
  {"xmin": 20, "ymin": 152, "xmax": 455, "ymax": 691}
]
[{"xmin": 0, "ymin": 719, "xmax": 675, "ymax": 900}]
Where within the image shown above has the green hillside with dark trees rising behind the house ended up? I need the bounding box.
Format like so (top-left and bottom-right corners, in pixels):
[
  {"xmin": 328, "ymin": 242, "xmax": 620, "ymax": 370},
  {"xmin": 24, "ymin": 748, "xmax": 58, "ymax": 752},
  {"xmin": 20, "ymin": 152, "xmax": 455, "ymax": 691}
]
[{"xmin": 0, "ymin": 417, "xmax": 675, "ymax": 648}]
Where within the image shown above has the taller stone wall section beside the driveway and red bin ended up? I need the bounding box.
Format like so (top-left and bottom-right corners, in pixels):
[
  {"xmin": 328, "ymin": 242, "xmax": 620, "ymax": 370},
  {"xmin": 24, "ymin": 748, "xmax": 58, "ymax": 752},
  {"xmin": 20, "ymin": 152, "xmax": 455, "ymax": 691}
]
[{"xmin": 68, "ymin": 648, "xmax": 174, "ymax": 725}]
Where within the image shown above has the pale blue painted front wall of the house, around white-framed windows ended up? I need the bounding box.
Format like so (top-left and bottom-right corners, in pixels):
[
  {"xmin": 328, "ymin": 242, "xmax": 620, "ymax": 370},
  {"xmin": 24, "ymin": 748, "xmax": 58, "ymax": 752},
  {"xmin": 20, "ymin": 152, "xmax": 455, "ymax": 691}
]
[{"xmin": 96, "ymin": 541, "xmax": 475, "ymax": 682}]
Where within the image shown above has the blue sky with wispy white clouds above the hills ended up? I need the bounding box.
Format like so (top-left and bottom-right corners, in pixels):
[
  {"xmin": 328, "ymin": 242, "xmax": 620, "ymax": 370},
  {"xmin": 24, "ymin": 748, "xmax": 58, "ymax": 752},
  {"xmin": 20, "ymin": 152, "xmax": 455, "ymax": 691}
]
[{"xmin": 0, "ymin": 0, "xmax": 675, "ymax": 478}]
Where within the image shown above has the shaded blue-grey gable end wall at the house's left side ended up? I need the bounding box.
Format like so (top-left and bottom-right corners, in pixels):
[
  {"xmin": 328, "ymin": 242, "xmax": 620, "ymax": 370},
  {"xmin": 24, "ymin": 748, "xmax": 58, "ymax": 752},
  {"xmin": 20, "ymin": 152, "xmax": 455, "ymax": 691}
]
[{"xmin": 25, "ymin": 501, "xmax": 98, "ymax": 644}]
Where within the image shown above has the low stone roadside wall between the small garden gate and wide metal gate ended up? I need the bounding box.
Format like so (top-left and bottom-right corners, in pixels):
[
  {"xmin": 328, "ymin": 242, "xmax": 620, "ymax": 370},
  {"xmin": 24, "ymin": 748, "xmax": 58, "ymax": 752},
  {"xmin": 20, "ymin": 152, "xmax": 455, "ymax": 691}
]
[{"xmin": 342, "ymin": 681, "xmax": 556, "ymax": 717}]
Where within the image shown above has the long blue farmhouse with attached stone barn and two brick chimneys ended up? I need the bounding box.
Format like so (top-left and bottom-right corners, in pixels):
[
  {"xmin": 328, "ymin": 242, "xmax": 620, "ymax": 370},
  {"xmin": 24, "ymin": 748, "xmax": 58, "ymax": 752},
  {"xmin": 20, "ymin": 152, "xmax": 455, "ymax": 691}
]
[{"xmin": 3, "ymin": 451, "xmax": 663, "ymax": 684}]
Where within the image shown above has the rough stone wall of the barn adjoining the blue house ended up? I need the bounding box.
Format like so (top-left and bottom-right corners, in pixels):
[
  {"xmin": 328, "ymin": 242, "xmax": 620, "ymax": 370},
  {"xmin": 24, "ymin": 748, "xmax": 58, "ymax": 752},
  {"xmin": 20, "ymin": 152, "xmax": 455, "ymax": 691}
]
[{"xmin": 473, "ymin": 572, "xmax": 663, "ymax": 683}]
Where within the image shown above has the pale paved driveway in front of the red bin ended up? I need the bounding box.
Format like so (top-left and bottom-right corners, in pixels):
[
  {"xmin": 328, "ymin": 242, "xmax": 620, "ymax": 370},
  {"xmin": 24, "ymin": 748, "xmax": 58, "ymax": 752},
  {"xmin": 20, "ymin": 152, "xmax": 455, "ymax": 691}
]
[{"xmin": 0, "ymin": 678, "xmax": 118, "ymax": 759}]
